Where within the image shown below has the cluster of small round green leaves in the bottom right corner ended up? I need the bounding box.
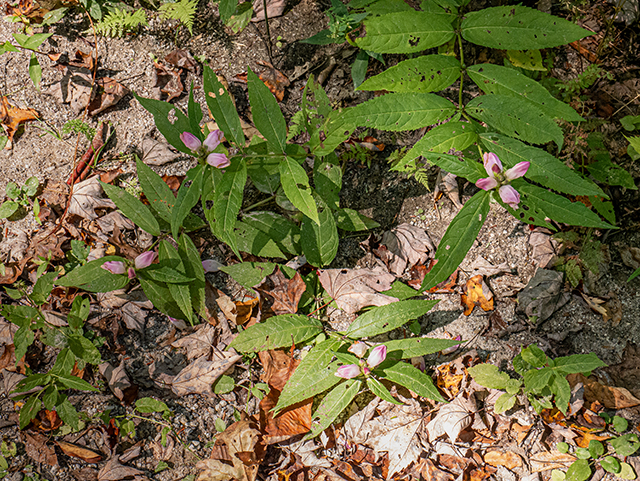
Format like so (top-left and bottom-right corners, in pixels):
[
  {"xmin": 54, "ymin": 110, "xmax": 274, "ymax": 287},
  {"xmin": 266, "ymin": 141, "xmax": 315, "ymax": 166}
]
[{"xmin": 551, "ymin": 413, "xmax": 640, "ymax": 481}]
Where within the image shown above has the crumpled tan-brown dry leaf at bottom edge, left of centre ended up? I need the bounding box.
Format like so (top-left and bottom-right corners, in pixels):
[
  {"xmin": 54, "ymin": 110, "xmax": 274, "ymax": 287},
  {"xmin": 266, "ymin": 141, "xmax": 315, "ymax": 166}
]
[{"xmin": 196, "ymin": 413, "xmax": 264, "ymax": 481}]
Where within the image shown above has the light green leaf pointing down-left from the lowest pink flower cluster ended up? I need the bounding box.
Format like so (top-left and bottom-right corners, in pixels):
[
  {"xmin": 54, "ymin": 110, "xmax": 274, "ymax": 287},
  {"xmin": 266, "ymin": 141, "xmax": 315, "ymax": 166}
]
[{"xmin": 274, "ymin": 339, "xmax": 341, "ymax": 414}]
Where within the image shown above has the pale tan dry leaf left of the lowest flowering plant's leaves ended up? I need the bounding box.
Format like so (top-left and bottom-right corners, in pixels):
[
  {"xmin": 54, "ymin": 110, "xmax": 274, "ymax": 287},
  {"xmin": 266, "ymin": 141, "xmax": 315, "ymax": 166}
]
[{"xmin": 171, "ymin": 349, "xmax": 242, "ymax": 396}]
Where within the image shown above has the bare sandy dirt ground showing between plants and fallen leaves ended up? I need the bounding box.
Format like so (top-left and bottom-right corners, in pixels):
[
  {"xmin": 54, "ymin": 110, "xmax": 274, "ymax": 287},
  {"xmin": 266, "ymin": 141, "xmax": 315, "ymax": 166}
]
[{"xmin": 0, "ymin": 0, "xmax": 640, "ymax": 481}]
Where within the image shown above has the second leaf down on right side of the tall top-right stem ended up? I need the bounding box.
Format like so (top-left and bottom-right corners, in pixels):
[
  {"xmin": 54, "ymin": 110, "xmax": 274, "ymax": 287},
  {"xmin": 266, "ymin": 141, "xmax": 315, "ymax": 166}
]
[{"xmin": 467, "ymin": 63, "xmax": 584, "ymax": 122}]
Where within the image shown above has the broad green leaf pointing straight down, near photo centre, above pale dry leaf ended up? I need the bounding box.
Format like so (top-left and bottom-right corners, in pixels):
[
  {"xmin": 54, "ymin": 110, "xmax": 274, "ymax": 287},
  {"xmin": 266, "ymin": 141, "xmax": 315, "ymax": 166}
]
[{"xmin": 300, "ymin": 199, "xmax": 338, "ymax": 267}]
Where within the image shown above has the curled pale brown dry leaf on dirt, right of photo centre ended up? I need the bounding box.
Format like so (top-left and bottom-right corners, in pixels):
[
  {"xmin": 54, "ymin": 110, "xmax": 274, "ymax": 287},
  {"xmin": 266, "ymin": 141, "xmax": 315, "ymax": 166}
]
[{"xmin": 380, "ymin": 224, "xmax": 435, "ymax": 276}]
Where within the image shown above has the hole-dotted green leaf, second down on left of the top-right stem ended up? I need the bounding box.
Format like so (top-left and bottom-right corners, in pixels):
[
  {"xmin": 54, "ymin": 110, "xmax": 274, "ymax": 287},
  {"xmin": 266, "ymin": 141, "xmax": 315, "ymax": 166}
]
[{"xmin": 358, "ymin": 55, "xmax": 460, "ymax": 93}]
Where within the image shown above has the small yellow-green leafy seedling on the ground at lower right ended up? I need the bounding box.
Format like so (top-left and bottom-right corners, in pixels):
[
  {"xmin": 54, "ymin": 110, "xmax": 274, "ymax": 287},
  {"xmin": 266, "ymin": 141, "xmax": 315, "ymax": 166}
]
[{"xmin": 469, "ymin": 344, "xmax": 605, "ymax": 414}]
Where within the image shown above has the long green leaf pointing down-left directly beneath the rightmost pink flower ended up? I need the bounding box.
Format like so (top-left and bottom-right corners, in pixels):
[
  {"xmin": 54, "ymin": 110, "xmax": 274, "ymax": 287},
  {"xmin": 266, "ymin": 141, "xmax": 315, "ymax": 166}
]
[{"xmin": 420, "ymin": 191, "xmax": 490, "ymax": 292}]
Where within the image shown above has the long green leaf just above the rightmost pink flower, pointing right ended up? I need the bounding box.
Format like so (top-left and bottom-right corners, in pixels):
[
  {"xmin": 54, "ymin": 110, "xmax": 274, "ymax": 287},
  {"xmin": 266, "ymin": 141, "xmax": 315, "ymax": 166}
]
[{"xmin": 476, "ymin": 133, "xmax": 604, "ymax": 196}]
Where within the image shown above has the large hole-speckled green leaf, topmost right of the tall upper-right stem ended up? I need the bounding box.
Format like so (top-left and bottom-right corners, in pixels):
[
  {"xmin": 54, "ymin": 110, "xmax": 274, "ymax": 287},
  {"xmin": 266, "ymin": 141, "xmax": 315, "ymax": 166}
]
[{"xmin": 461, "ymin": 5, "xmax": 593, "ymax": 50}]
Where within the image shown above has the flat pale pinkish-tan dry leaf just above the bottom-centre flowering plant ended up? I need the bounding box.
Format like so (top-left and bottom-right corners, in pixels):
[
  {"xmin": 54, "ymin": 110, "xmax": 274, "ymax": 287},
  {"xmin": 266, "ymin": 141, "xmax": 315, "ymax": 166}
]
[{"xmin": 318, "ymin": 268, "xmax": 398, "ymax": 314}]
